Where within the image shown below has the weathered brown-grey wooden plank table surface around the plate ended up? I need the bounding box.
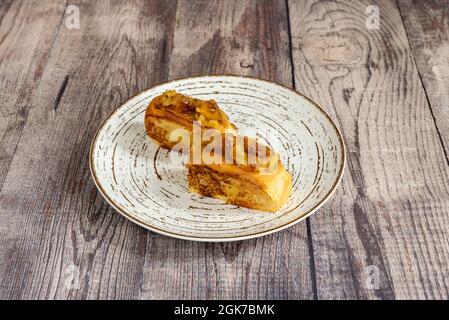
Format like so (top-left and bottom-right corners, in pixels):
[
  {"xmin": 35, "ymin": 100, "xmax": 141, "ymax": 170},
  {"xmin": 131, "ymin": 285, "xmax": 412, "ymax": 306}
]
[{"xmin": 0, "ymin": 0, "xmax": 449, "ymax": 299}]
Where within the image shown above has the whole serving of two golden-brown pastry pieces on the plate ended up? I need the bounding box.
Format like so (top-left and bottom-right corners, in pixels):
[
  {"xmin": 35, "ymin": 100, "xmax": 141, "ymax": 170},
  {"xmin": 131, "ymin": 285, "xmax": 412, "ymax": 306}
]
[{"xmin": 145, "ymin": 91, "xmax": 292, "ymax": 212}]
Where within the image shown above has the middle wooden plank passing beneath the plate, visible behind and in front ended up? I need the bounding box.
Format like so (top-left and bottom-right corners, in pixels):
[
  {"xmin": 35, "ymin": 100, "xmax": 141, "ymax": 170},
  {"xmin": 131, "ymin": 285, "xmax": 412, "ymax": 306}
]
[{"xmin": 142, "ymin": 0, "xmax": 313, "ymax": 299}]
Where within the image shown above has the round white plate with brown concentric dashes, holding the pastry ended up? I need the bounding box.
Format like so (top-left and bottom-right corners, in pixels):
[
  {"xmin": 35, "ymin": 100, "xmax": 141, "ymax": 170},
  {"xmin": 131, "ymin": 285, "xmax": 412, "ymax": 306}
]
[{"xmin": 89, "ymin": 76, "xmax": 345, "ymax": 241}]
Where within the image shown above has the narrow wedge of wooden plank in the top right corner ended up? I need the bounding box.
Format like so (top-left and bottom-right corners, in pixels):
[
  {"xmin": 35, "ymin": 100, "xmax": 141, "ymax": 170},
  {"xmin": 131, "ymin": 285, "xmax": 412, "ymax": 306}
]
[{"xmin": 398, "ymin": 0, "xmax": 449, "ymax": 163}]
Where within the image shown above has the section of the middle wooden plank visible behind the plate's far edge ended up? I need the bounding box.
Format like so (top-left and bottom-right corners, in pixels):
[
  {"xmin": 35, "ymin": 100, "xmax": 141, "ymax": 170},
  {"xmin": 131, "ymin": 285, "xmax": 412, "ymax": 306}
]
[{"xmin": 170, "ymin": 0, "xmax": 292, "ymax": 86}]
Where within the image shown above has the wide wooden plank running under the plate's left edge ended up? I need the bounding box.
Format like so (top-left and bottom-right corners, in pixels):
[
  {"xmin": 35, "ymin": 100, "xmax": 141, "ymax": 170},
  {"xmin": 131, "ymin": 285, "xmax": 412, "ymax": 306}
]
[{"xmin": 0, "ymin": 0, "xmax": 176, "ymax": 299}]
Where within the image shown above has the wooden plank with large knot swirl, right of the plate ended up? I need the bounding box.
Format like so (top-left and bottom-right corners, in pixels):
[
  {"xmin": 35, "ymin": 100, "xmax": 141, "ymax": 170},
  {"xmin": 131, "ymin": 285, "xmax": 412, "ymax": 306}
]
[{"xmin": 289, "ymin": 0, "xmax": 449, "ymax": 299}]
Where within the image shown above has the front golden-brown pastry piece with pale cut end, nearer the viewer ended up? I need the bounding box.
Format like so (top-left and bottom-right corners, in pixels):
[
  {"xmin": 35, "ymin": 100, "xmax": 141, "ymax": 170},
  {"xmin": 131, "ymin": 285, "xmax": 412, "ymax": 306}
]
[{"xmin": 187, "ymin": 134, "xmax": 292, "ymax": 212}]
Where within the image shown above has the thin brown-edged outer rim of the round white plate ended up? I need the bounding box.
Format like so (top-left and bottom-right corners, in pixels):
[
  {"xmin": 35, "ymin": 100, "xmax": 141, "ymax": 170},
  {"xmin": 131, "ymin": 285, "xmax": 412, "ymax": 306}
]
[{"xmin": 89, "ymin": 74, "xmax": 346, "ymax": 242}]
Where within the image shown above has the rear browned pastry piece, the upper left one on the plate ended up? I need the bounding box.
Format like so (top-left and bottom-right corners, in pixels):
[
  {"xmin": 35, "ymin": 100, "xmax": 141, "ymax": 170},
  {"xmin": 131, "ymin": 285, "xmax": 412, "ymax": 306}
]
[{"xmin": 145, "ymin": 90, "xmax": 237, "ymax": 149}]
